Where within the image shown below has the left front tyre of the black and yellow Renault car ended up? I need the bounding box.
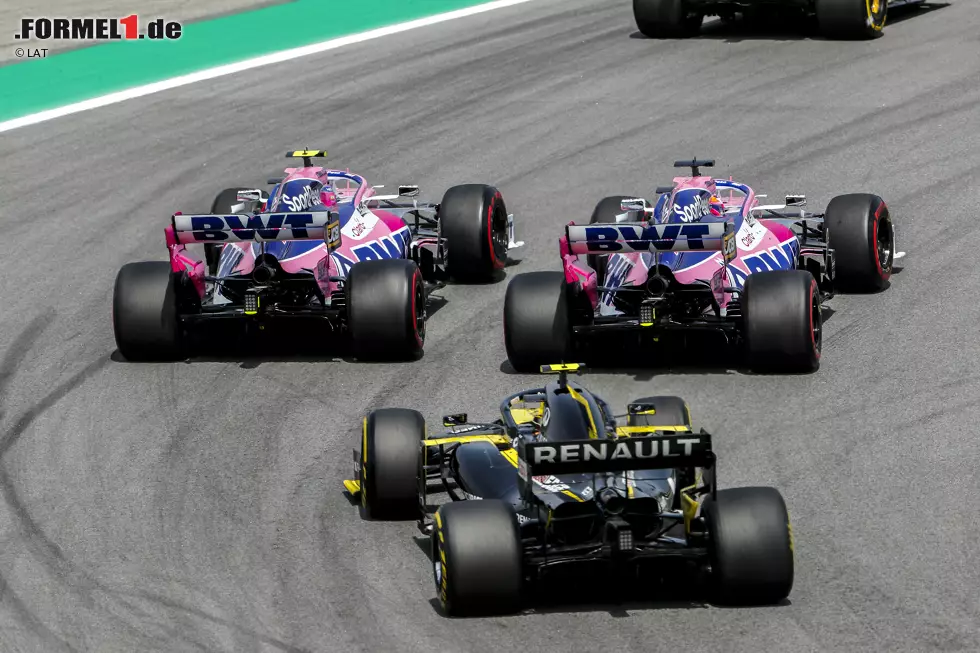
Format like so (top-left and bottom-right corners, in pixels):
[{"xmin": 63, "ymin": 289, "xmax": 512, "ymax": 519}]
[{"xmin": 359, "ymin": 408, "xmax": 425, "ymax": 521}]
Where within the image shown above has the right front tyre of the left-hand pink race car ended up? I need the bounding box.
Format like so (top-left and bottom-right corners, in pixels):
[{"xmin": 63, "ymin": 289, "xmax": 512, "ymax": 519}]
[{"xmin": 439, "ymin": 184, "xmax": 509, "ymax": 283}]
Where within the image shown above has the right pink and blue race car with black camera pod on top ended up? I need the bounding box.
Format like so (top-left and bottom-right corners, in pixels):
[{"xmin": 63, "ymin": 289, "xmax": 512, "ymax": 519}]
[{"xmin": 504, "ymin": 160, "xmax": 904, "ymax": 372}]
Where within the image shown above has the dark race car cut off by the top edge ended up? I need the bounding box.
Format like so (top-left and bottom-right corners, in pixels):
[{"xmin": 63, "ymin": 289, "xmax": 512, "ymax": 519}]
[{"xmin": 633, "ymin": 0, "xmax": 925, "ymax": 40}]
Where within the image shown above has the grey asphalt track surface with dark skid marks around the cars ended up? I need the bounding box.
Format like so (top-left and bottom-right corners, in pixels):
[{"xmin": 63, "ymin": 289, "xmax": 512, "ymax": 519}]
[{"xmin": 0, "ymin": 0, "xmax": 980, "ymax": 653}]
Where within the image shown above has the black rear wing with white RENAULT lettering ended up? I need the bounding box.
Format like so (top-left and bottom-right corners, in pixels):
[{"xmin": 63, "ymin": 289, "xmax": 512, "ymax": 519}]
[{"xmin": 517, "ymin": 429, "xmax": 715, "ymax": 482}]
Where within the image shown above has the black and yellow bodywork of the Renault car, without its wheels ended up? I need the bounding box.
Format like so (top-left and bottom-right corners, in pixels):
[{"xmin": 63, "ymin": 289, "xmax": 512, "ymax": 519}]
[{"xmin": 410, "ymin": 372, "xmax": 717, "ymax": 580}]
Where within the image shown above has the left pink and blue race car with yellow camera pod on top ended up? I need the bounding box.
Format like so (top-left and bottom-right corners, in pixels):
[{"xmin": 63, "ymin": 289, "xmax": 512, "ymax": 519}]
[{"xmin": 113, "ymin": 150, "xmax": 523, "ymax": 361}]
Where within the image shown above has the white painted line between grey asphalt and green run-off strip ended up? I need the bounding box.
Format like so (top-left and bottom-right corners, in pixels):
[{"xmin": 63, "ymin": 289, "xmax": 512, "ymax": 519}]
[{"xmin": 0, "ymin": 0, "xmax": 533, "ymax": 132}]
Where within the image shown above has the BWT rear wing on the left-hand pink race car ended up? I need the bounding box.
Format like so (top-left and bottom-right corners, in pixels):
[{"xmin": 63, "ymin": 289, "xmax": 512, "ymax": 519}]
[{"xmin": 172, "ymin": 211, "xmax": 340, "ymax": 250}]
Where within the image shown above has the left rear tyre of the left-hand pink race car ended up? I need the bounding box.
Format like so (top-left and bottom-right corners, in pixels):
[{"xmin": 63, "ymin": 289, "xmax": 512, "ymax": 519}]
[{"xmin": 112, "ymin": 261, "xmax": 183, "ymax": 362}]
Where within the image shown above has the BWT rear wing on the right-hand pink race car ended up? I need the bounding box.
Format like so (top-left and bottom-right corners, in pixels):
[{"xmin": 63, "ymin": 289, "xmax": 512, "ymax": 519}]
[{"xmin": 565, "ymin": 222, "xmax": 735, "ymax": 261}]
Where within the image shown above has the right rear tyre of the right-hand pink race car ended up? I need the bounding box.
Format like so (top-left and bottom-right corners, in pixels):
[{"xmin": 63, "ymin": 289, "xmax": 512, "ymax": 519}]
[{"xmin": 742, "ymin": 270, "xmax": 823, "ymax": 374}]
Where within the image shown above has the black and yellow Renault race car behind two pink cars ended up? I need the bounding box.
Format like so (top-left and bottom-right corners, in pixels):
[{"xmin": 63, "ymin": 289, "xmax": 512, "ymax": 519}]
[{"xmin": 344, "ymin": 364, "xmax": 794, "ymax": 615}]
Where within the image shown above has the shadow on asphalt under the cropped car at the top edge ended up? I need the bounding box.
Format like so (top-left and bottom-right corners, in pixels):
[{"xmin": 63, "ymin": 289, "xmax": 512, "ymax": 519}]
[{"xmin": 630, "ymin": 2, "xmax": 950, "ymax": 43}]
